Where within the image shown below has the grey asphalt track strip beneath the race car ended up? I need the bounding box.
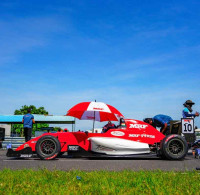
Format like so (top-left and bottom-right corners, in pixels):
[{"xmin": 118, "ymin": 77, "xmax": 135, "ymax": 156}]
[{"xmin": 0, "ymin": 150, "xmax": 200, "ymax": 171}]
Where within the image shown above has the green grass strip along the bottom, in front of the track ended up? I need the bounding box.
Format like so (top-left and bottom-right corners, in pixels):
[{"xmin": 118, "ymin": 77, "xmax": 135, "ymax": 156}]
[{"xmin": 0, "ymin": 169, "xmax": 200, "ymax": 195}]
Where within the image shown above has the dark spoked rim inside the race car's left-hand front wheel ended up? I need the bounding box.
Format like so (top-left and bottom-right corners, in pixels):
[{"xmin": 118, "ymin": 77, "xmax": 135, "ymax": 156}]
[{"xmin": 40, "ymin": 139, "xmax": 56, "ymax": 156}]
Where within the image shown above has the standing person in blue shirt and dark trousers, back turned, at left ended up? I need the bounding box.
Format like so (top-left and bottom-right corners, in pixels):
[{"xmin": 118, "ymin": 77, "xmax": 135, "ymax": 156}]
[{"xmin": 22, "ymin": 109, "xmax": 35, "ymax": 142}]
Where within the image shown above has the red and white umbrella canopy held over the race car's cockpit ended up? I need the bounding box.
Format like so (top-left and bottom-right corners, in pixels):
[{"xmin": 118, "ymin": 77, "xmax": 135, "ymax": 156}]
[{"xmin": 67, "ymin": 102, "xmax": 124, "ymax": 122}]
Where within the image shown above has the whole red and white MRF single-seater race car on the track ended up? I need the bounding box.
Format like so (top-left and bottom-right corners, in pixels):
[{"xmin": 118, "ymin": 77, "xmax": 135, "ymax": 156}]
[{"xmin": 7, "ymin": 119, "xmax": 188, "ymax": 160}]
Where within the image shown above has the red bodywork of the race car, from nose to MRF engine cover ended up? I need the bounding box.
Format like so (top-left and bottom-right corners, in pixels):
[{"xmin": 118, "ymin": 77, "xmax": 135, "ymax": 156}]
[{"xmin": 16, "ymin": 119, "xmax": 165, "ymax": 152}]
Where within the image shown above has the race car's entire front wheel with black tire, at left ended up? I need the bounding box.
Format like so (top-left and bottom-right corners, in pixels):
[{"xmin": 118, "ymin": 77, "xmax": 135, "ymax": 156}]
[{"xmin": 35, "ymin": 135, "xmax": 61, "ymax": 160}]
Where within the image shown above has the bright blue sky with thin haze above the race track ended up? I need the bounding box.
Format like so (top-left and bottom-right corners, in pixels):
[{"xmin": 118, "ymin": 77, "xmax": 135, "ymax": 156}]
[{"xmin": 0, "ymin": 0, "xmax": 200, "ymax": 130}]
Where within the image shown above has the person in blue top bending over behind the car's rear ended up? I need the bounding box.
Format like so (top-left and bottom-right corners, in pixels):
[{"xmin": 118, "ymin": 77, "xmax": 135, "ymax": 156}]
[{"xmin": 144, "ymin": 114, "xmax": 173, "ymax": 135}]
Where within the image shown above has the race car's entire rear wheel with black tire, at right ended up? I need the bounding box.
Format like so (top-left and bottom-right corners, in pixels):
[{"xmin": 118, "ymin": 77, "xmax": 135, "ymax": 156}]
[{"xmin": 161, "ymin": 135, "xmax": 188, "ymax": 160}]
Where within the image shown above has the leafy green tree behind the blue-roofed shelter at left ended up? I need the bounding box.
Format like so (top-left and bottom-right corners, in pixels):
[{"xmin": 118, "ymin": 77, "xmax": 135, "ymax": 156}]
[{"xmin": 13, "ymin": 105, "xmax": 49, "ymax": 136}]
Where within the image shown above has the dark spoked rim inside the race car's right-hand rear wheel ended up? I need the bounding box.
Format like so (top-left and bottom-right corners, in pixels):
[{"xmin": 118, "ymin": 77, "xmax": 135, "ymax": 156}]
[{"xmin": 168, "ymin": 139, "xmax": 184, "ymax": 156}]
